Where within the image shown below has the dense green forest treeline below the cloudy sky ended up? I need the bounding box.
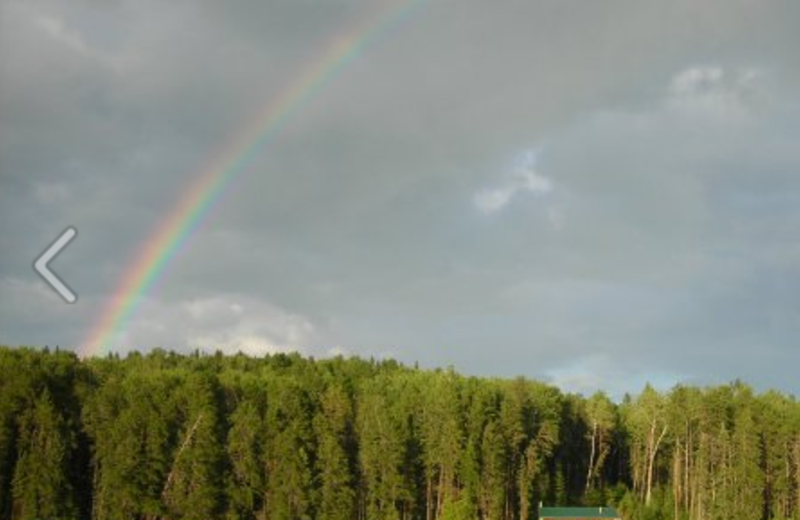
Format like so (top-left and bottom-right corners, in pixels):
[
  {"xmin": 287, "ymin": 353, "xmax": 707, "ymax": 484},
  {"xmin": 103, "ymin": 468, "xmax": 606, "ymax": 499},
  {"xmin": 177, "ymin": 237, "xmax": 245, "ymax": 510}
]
[{"xmin": 0, "ymin": 347, "xmax": 800, "ymax": 520}]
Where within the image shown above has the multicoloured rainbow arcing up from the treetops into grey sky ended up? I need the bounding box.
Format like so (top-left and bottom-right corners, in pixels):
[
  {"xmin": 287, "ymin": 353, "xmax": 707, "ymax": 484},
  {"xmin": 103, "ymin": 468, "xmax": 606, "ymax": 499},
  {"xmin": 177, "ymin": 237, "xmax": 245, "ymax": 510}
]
[{"xmin": 78, "ymin": 0, "xmax": 426, "ymax": 358}]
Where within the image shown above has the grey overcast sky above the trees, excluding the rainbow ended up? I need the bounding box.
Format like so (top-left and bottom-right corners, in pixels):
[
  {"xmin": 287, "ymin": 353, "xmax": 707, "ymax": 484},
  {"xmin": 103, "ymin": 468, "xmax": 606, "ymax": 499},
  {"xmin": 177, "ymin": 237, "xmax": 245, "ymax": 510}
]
[{"xmin": 0, "ymin": 0, "xmax": 800, "ymax": 395}]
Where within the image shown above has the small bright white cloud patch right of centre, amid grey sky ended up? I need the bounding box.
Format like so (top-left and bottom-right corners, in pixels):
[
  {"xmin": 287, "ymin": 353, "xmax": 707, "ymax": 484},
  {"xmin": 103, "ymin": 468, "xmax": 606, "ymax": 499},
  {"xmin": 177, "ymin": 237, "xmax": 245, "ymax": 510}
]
[{"xmin": 473, "ymin": 150, "xmax": 553, "ymax": 214}]
